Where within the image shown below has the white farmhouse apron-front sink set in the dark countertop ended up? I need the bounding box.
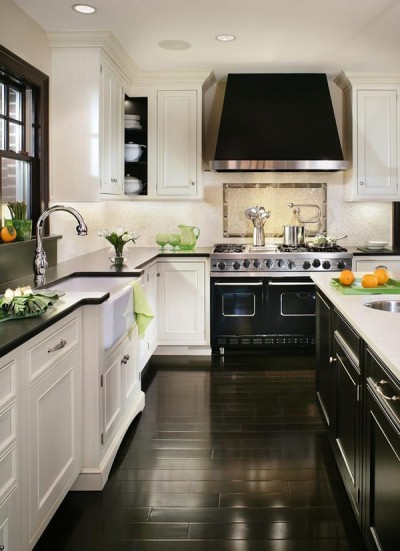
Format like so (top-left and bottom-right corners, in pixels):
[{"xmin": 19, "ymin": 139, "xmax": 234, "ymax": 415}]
[{"xmin": 47, "ymin": 276, "xmax": 137, "ymax": 350}]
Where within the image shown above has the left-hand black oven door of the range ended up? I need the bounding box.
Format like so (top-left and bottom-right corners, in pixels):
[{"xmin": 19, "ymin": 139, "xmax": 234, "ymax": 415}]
[{"xmin": 211, "ymin": 276, "xmax": 266, "ymax": 338}]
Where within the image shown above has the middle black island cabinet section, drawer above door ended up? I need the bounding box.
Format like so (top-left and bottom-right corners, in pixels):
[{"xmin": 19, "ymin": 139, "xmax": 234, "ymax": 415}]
[{"xmin": 332, "ymin": 312, "xmax": 362, "ymax": 523}]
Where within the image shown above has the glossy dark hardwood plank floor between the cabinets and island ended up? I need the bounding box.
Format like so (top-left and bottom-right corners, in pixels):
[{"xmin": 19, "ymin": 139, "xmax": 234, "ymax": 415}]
[{"xmin": 35, "ymin": 353, "xmax": 365, "ymax": 551}]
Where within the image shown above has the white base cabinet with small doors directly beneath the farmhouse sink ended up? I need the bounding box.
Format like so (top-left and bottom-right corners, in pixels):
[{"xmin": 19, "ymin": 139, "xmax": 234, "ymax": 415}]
[{"xmin": 73, "ymin": 302, "xmax": 145, "ymax": 491}]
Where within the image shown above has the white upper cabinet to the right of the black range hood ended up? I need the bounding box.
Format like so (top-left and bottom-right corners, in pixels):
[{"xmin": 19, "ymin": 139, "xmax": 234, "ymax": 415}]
[{"xmin": 335, "ymin": 73, "xmax": 400, "ymax": 201}]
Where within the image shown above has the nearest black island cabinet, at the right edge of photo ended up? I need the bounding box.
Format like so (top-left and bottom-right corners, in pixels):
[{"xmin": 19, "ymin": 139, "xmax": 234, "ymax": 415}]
[{"xmin": 364, "ymin": 348, "xmax": 400, "ymax": 551}]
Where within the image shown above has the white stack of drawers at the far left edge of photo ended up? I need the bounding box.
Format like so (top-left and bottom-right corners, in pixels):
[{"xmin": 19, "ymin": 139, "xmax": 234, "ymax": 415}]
[{"xmin": 0, "ymin": 354, "xmax": 17, "ymax": 551}]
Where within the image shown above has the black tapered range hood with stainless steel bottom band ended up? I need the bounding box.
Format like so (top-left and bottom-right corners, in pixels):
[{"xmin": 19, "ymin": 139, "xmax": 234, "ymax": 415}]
[{"xmin": 210, "ymin": 73, "xmax": 349, "ymax": 172}]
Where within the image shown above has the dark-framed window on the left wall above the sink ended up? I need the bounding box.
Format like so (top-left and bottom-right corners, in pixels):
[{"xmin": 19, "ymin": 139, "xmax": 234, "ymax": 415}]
[{"xmin": 0, "ymin": 46, "xmax": 48, "ymax": 234}]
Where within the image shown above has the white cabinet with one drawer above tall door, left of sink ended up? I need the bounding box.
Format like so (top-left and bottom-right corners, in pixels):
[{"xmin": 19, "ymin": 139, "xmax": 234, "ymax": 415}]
[{"xmin": 21, "ymin": 312, "xmax": 82, "ymax": 546}]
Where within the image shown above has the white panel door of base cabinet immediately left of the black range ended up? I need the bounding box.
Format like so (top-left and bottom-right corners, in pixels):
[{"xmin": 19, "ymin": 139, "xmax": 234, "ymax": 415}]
[{"xmin": 158, "ymin": 262, "xmax": 207, "ymax": 345}]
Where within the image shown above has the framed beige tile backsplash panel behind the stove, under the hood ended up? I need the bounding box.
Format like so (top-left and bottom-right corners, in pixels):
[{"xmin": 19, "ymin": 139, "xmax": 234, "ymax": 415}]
[{"xmin": 223, "ymin": 183, "xmax": 326, "ymax": 237}]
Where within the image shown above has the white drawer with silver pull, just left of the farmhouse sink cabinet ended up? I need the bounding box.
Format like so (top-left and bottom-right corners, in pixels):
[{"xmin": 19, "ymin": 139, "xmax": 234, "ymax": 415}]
[{"xmin": 28, "ymin": 318, "xmax": 79, "ymax": 381}]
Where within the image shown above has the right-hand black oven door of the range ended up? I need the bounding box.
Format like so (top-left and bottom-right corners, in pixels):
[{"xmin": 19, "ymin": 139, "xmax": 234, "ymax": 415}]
[{"xmin": 267, "ymin": 277, "xmax": 315, "ymax": 342}]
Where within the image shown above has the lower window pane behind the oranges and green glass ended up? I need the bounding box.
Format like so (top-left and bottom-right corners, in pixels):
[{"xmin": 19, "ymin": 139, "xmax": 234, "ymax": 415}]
[{"xmin": 0, "ymin": 157, "xmax": 31, "ymax": 218}]
